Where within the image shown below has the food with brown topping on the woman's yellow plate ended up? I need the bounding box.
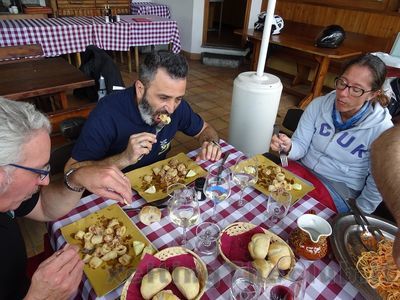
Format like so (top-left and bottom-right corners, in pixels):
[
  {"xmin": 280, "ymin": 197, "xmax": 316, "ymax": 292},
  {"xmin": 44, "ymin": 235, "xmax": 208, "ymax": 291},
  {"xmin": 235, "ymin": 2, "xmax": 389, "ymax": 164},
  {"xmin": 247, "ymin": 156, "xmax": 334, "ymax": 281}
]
[{"xmin": 257, "ymin": 165, "xmax": 302, "ymax": 192}]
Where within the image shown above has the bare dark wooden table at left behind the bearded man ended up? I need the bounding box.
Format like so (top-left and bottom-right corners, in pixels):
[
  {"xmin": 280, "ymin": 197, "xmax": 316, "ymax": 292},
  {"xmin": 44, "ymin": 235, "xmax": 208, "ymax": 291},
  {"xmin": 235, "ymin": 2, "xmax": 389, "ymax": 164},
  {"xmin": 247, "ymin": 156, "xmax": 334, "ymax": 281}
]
[{"xmin": 0, "ymin": 58, "xmax": 94, "ymax": 109}]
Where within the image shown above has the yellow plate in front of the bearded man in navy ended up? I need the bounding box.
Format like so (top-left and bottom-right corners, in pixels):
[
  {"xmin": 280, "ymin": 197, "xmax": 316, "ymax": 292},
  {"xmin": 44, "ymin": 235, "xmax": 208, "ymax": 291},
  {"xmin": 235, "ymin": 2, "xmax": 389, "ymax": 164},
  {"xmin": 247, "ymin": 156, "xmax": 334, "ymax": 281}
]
[{"xmin": 125, "ymin": 153, "xmax": 207, "ymax": 202}]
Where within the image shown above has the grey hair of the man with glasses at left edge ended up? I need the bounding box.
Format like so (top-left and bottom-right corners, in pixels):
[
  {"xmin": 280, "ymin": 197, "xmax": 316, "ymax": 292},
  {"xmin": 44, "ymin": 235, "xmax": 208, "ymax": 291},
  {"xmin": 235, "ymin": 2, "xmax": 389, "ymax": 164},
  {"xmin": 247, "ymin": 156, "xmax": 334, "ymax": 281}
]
[{"xmin": 0, "ymin": 96, "xmax": 51, "ymax": 166}]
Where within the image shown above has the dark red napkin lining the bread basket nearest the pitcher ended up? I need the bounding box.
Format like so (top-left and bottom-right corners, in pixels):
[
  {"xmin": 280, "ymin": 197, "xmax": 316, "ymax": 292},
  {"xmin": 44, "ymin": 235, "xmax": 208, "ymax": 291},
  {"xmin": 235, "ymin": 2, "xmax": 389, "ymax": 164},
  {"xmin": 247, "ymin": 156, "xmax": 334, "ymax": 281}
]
[{"xmin": 221, "ymin": 227, "xmax": 264, "ymax": 266}]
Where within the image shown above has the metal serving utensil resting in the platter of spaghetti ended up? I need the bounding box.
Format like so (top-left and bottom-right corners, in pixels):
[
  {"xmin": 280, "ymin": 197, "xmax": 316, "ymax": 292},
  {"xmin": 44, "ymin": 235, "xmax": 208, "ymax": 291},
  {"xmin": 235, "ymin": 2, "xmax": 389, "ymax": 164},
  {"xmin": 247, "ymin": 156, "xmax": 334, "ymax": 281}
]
[{"xmin": 348, "ymin": 199, "xmax": 385, "ymax": 251}]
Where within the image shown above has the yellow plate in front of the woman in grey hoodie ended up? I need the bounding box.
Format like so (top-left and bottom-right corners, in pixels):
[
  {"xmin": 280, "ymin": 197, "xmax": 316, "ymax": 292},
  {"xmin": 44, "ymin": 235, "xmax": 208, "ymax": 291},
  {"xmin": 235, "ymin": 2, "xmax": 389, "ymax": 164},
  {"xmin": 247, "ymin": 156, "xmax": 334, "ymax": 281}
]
[{"xmin": 254, "ymin": 154, "xmax": 314, "ymax": 204}]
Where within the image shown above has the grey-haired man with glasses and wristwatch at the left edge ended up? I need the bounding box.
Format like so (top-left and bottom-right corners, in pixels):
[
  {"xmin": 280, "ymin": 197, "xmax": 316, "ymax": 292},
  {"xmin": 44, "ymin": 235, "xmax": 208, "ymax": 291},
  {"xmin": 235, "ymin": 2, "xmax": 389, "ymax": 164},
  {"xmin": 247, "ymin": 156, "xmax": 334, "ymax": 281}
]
[{"xmin": 0, "ymin": 97, "xmax": 132, "ymax": 299}]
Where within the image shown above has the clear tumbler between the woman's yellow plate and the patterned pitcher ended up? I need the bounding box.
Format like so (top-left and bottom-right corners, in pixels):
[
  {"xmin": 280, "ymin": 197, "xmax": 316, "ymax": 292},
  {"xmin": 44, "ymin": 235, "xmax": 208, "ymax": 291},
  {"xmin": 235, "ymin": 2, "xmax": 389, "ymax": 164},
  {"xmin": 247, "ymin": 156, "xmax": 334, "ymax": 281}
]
[{"xmin": 266, "ymin": 190, "xmax": 292, "ymax": 227}]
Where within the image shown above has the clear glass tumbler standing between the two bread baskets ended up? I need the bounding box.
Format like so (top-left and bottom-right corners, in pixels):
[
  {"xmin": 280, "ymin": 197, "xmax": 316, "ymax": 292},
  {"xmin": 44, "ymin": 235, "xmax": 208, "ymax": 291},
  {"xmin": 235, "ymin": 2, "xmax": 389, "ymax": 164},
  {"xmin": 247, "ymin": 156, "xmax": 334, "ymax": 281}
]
[{"xmin": 196, "ymin": 222, "xmax": 221, "ymax": 255}]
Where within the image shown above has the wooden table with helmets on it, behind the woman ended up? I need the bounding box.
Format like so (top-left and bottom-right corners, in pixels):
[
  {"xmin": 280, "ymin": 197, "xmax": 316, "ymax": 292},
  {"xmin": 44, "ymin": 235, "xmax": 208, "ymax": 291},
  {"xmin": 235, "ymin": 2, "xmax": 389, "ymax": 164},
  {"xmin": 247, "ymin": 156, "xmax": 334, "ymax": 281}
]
[{"xmin": 239, "ymin": 21, "xmax": 386, "ymax": 108}]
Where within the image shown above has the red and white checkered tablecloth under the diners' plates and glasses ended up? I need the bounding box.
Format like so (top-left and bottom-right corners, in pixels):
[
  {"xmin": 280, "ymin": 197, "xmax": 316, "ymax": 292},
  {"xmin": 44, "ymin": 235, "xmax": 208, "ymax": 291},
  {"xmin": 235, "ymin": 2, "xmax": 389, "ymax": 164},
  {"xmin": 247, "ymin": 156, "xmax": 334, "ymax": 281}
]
[{"xmin": 48, "ymin": 142, "xmax": 363, "ymax": 300}]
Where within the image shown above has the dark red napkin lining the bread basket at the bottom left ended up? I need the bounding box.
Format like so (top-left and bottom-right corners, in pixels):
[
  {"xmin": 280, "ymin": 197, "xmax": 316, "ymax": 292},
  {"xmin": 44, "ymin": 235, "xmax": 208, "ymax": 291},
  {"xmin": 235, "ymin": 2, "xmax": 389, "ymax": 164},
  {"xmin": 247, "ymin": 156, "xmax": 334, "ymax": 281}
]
[{"xmin": 126, "ymin": 254, "xmax": 196, "ymax": 300}]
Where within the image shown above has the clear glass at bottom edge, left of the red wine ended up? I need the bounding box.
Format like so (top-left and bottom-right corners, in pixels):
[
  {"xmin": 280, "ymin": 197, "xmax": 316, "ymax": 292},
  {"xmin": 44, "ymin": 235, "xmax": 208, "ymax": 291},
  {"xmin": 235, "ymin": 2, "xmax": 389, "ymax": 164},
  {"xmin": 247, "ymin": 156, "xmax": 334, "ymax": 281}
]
[{"xmin": 230, "ymin": 267, "xmax": 263, "ymax": 300}]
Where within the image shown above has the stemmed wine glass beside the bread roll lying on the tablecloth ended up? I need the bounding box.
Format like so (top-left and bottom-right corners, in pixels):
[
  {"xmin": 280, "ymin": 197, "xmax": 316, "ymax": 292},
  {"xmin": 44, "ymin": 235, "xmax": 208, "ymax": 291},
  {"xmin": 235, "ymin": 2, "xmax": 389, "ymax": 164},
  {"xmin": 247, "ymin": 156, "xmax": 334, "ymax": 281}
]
[{"xmin": 167, "ymin": 183, "xmax": 200, "ymax": 247}]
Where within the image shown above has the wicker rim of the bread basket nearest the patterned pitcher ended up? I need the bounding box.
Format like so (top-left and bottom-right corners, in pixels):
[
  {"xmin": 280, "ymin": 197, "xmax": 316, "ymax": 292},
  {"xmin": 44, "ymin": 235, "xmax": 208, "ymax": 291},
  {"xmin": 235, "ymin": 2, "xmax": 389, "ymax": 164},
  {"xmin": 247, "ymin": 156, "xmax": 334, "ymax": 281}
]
[{"xmin": 218, "ymin": 222, "xmax": 295, "ymax": 268}]
